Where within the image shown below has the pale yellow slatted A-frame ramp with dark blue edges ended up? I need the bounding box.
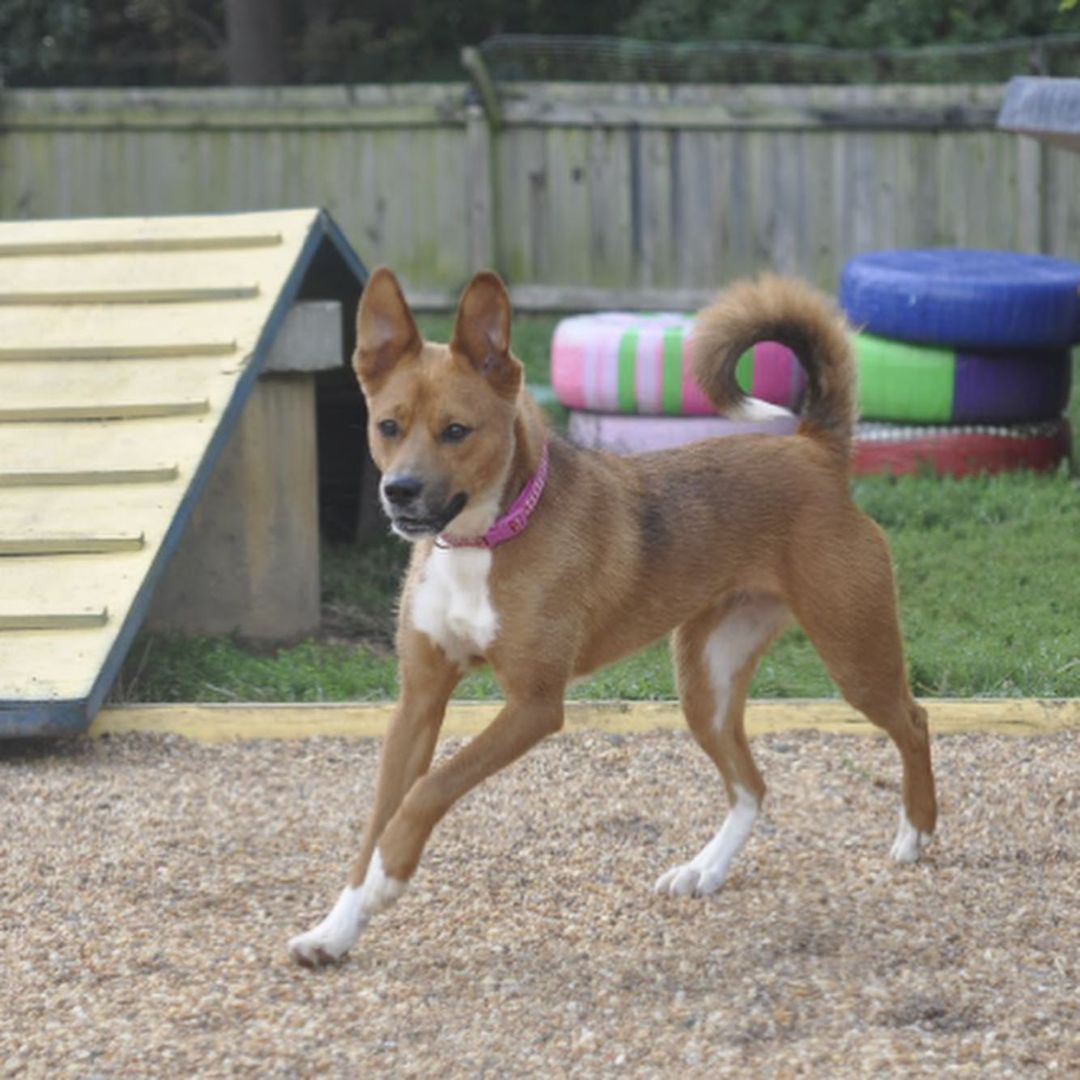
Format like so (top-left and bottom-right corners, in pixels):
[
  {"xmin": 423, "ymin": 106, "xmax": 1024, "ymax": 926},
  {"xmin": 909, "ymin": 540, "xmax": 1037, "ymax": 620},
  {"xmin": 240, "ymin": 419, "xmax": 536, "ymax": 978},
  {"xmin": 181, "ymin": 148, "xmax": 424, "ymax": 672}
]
[{"xmin": 0, "ymin": 210, "xmax": 367, "ymax": 737}]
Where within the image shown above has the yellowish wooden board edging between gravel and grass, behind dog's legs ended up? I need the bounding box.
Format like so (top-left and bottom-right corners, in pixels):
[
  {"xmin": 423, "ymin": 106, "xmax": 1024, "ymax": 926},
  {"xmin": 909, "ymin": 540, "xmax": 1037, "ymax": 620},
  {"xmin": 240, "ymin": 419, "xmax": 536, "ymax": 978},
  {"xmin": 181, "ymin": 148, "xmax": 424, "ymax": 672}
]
[{"xmin": 90, "ymin": 698, "xmax": 1080, "ymax": 743}]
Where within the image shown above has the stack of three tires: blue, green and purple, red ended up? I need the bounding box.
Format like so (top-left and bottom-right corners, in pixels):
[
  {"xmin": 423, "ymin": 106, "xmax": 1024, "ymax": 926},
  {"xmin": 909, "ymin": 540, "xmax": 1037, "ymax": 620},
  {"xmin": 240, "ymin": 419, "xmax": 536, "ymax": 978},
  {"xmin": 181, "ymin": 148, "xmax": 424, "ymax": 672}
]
[{"xmin": 839, "ymin": 249, "xmax": 1080, "ymax": 476}]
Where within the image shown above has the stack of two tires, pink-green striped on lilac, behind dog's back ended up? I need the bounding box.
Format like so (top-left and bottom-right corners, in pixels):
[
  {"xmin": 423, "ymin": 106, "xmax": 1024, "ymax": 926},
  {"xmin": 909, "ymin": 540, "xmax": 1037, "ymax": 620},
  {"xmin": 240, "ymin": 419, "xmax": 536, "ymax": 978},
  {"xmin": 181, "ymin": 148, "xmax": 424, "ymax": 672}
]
[{"xmin": 551, "ymin": 312, "xmax": 806, "ymax": 454}]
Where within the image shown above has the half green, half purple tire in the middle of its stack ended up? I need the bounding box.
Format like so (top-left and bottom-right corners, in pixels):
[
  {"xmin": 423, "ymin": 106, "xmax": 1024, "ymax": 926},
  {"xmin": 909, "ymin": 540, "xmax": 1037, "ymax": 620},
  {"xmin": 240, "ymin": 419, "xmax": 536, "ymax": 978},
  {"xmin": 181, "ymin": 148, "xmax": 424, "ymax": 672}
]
[{"xmin": 854, "ymin": 334, "xmax": 1072, "ymax": 423}]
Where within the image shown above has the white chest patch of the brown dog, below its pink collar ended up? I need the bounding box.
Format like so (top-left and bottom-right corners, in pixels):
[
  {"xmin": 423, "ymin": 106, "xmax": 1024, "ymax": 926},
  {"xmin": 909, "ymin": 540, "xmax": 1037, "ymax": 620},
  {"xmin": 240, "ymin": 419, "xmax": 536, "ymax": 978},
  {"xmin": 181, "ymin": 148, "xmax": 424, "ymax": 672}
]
[{"xmin": 409, "ymin": 548, "xmax": 499, "ymax": 664}]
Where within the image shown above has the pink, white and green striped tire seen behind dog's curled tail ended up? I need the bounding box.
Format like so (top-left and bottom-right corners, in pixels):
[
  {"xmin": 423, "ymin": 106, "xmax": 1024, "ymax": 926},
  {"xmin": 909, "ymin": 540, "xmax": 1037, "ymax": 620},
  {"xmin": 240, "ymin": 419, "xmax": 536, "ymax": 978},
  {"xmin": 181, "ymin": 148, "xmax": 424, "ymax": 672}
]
[{"xmin": 551, "ymin": 311, "xmax": 806, "ymax": 416}]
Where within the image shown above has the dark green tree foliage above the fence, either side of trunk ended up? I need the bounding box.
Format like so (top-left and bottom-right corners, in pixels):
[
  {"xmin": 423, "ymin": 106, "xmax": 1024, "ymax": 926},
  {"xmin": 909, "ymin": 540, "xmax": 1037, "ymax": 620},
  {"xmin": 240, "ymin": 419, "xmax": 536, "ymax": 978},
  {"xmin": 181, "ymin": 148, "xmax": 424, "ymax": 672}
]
[{"xmin": 0, "ymin": 0, "xmax": 1077, "ymax": 85}]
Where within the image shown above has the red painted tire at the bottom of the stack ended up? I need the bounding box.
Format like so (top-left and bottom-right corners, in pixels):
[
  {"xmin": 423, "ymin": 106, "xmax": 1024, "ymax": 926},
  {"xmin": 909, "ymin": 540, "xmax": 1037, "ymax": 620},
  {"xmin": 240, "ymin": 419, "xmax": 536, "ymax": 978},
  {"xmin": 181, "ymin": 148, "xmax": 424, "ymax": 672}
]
[{"xmin": 852, "ymin": 417, "xmax": 1072, "ymax": 476}]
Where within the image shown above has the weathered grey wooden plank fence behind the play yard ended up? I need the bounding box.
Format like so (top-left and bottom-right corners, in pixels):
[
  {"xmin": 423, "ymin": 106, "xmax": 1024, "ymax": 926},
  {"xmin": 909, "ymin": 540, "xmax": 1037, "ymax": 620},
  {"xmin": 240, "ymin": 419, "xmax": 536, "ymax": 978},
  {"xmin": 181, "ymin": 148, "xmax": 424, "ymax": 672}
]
[{"xmin": 0, "ymin": 83, "xmax": 1080, "ymax": 309}]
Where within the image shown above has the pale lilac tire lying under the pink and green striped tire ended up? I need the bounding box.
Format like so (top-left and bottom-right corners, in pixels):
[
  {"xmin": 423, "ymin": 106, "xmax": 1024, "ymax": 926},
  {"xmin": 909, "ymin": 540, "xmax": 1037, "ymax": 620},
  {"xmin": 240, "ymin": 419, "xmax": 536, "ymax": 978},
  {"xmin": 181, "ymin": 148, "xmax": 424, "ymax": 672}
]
[{"xmin": 568, "ymin": 409, "xmax": 799, "ymax": 454}]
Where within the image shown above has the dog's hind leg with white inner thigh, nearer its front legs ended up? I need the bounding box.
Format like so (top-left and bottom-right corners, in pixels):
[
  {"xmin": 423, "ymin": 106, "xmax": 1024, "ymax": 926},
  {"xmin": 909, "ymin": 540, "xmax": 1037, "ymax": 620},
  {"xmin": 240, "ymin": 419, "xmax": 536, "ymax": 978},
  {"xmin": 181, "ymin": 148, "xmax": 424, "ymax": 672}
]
[{"xmin": 656, "ymin": 596, "xmax": 788, "ymax": 896}]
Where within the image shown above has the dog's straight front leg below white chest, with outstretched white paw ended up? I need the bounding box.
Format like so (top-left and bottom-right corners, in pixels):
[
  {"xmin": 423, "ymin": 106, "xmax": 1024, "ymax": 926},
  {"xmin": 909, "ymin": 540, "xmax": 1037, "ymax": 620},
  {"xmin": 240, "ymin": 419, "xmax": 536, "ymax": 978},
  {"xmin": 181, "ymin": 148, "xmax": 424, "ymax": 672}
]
[{"xmin": 288, "ymin": 635, "xmax": 461, "ymax": 968}]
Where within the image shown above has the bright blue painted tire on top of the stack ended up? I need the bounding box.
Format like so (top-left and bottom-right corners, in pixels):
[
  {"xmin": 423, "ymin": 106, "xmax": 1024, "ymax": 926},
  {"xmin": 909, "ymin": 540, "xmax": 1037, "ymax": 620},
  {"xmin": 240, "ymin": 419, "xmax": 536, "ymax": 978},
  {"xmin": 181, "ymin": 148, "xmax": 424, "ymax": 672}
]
[{"xmin": 839, "ymin": 248, "xmax": 1080, "ymax": 349}]
